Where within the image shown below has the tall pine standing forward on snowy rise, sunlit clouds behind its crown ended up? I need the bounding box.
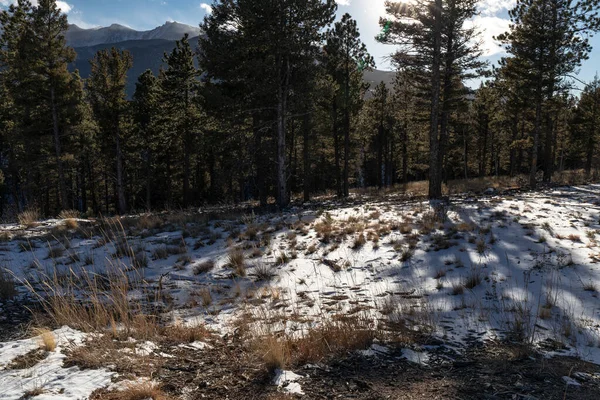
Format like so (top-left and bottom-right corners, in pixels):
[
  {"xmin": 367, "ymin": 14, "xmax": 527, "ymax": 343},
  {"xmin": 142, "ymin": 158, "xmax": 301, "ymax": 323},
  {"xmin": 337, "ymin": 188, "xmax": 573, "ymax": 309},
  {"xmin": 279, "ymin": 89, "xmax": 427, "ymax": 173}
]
[{"xmin": 378, "ymin": 0, "xmax": 483, "ymax": 199}]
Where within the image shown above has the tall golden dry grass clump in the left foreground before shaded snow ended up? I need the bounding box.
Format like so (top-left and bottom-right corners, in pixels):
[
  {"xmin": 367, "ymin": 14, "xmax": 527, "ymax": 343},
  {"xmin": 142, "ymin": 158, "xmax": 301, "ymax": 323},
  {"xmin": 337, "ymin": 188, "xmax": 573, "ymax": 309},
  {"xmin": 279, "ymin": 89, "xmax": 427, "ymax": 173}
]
[{"xmin": 22, "ymin": 222, "xmax": 162, "ymax": 338}]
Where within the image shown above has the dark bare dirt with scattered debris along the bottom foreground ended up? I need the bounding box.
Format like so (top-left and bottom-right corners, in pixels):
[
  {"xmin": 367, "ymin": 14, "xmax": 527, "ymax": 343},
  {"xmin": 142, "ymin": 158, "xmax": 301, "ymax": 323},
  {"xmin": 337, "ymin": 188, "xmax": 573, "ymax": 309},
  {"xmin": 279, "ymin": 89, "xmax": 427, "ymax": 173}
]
[{"xmin": 85, "ymin": 340, "xmax": 600, "ymax": 400}]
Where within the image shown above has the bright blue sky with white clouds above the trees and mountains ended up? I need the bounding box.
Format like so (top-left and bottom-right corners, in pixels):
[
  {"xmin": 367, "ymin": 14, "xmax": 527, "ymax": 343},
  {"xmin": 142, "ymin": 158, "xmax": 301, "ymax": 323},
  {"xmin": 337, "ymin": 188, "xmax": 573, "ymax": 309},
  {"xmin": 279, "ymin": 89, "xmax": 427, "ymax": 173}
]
[{"xmin": 0, "ymin": 0, "xmax": 600, "ymax": 87}]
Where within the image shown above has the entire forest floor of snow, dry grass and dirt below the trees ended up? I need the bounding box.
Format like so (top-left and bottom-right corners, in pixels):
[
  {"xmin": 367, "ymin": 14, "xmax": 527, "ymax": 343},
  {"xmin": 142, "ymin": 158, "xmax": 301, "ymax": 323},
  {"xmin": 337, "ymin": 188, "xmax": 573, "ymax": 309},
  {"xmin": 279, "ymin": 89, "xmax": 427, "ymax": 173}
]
[{"xmin": 0, "ymin": 185, "xmax": 600, "ymax": 400}]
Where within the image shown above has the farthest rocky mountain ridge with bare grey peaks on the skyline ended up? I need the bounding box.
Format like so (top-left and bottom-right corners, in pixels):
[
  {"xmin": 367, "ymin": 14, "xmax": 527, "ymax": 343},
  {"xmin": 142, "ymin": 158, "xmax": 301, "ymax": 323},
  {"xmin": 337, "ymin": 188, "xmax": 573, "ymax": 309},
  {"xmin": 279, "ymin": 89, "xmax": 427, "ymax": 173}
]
[{"xmin": 65, "ymin": 22, "xmax": 200, "ymax": 47}]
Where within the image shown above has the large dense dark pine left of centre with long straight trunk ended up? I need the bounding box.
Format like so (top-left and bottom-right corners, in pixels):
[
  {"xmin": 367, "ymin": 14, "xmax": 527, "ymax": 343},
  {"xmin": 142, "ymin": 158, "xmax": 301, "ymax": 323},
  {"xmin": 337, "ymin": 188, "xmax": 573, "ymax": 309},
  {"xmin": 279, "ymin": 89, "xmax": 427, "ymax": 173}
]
[{"xmin": 200, "ymin": 0, "xmax": 336, "ymax": 207}]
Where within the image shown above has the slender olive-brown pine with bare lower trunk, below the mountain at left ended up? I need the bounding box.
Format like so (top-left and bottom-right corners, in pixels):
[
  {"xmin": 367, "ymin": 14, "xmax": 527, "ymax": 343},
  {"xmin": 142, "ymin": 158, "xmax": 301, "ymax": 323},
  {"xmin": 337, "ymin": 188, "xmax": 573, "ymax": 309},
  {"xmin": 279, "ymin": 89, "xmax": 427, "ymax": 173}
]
[{"xmin": 87, "ymin": 47, "xmax": 133, "ymax": 214}]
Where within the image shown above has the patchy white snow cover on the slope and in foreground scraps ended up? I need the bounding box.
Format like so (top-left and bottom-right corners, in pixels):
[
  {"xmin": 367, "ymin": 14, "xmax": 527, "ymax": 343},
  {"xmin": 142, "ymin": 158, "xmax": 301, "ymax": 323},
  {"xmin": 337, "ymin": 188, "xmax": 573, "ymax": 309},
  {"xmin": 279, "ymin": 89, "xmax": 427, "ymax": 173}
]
[{"xmin": 0, "ymin": 185, "xmax": 600, "ymax": 399}]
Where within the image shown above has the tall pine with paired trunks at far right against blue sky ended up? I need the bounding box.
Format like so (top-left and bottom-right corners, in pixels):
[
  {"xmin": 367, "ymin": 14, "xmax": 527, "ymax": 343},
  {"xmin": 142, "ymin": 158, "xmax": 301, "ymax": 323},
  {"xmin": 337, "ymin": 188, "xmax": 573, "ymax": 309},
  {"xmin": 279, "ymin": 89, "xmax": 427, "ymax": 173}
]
[{"xmin": 498, "ymin": 0, "xmax": 600, "ymax": 188}]
